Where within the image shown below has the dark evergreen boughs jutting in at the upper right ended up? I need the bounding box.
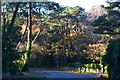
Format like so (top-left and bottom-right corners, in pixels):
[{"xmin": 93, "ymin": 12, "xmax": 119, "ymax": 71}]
[{"xmin": 92, "ymin": 2, "xmax": 120, "ymax": 34}]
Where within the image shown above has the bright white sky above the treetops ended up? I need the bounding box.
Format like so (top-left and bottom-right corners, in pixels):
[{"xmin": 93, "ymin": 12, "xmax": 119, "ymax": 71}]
[{"xmin": 53, "ymin": 0, "xmax": 106, "ymax": 11}]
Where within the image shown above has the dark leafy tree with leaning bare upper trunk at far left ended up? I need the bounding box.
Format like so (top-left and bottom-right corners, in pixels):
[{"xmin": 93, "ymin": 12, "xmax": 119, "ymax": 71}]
[{"xmin": 2, "ymin": 3, "xmax": 20, "ymax": 74}]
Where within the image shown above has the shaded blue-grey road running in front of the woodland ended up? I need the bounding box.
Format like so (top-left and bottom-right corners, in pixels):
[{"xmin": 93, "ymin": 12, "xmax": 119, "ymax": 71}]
[{"xmin": 30, "ymin": 69, "xmax": 98, "ymax": 80}]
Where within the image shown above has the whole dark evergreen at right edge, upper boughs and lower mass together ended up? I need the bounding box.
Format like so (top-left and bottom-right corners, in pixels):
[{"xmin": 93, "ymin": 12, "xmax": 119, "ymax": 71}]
[{"xmin": 93, "ymin": 1, "xmax": 120, "ymax": 79}]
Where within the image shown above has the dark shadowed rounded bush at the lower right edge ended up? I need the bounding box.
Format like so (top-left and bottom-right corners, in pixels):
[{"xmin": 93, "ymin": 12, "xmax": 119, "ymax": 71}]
[{"xmin": 103, "ymin": 39, "xmax": 120, "ymax": 78}]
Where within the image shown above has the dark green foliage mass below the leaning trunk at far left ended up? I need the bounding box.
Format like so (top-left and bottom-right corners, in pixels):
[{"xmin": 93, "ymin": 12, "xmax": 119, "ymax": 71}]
[{"xmin": 2, "ymin": 24, "xmax": 20, "ymax": 73}]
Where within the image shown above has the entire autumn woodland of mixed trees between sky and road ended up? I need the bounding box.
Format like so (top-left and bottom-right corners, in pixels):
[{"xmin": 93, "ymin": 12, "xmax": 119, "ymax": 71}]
[{"xmin": 1, "ymin": 1, "xmax": 120, "ymax": 78}]
